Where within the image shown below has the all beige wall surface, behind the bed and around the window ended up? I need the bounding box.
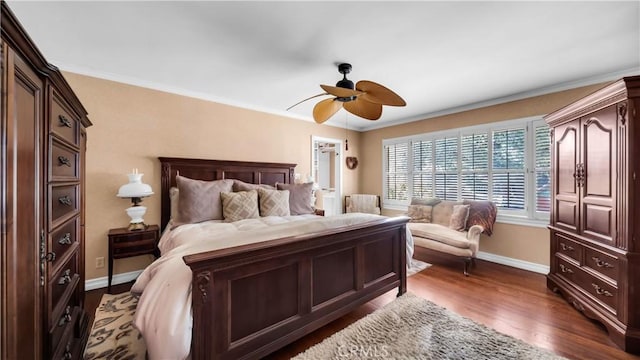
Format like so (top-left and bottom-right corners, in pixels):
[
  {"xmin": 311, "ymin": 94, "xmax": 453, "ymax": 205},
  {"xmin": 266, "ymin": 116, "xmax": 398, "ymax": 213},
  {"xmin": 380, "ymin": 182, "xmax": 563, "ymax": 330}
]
[{"xmin": 64, "ymin": 69, "xmax": 602, "ymax": 280}]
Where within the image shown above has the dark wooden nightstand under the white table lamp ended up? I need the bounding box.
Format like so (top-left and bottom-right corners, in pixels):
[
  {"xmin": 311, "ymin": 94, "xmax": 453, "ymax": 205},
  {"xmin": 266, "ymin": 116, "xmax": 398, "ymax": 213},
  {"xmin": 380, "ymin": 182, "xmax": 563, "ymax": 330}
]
[{"xmin": 107, "ymin": 225, "xmax": 160, "ymax": 294}]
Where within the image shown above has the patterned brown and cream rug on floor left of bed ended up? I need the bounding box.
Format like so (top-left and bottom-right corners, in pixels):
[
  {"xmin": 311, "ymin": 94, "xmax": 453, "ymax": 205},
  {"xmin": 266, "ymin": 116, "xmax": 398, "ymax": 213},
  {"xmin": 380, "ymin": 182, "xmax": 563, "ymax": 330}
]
[{"xmin": 84, "ymin": 292, "xmax": 147, "ymax": 360}]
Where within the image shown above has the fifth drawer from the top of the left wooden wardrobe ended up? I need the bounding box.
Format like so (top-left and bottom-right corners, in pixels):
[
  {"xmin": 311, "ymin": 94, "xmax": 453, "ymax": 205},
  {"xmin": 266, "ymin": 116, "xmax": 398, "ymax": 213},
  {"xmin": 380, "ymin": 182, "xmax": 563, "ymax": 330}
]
[{"xmin": 47, "ymin": 251, "xmax": 80, "ymax": 326}]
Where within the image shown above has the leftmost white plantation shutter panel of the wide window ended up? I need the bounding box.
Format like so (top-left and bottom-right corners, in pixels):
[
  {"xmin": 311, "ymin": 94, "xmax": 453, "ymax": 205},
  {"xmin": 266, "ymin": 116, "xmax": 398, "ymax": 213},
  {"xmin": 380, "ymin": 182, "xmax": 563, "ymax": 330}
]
[{"xmin": 384, "ymin": 143, "xmax": 409, "ymax": 200}]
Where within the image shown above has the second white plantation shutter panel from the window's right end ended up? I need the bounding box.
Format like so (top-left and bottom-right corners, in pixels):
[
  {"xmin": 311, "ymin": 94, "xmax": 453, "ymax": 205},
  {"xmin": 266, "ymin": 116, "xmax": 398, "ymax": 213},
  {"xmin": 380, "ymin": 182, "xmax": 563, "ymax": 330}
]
[{"xmin": 492, "ymin": 128, "xmax": 526, "ymax": 210}]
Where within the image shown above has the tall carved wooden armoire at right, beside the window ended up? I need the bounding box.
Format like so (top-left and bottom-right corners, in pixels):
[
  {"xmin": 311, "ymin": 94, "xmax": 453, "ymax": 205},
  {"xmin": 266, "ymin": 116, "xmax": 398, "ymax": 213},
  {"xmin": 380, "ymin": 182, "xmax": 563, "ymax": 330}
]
[{"xmin": 545, "ymin": 76, "xmax": 640, "ymax": 353}]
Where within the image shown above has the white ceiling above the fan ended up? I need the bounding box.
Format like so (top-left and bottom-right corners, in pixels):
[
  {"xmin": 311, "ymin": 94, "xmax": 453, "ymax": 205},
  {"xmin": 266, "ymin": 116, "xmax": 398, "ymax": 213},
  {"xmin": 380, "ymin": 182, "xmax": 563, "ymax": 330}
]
[{"xmin": 8, "ymin": 1, "xmax": 640, "ymax": 130}]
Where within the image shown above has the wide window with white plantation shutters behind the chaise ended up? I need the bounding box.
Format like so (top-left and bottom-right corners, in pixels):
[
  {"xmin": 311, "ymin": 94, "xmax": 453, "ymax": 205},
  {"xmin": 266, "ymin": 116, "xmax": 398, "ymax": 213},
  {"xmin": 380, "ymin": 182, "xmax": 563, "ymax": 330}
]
[{"xmin": 383, "ymin": 117, "xmax": 551, "ymax": 224}]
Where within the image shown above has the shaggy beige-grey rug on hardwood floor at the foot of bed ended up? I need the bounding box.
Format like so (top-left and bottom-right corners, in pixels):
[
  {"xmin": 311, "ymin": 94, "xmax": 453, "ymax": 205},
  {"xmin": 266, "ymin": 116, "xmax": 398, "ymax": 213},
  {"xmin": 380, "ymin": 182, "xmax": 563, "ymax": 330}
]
[{"xmin": 294, "ymin": 293, "xmax": 563, "ymax": 360}]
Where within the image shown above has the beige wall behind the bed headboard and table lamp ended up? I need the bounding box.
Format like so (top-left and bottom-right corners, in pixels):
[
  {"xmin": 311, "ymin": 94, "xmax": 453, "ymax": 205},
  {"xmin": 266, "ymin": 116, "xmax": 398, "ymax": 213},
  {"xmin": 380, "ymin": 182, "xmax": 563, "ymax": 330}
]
[{"xmin": 64, "ymin": 73, "xmax": 360, "ymax": 280}]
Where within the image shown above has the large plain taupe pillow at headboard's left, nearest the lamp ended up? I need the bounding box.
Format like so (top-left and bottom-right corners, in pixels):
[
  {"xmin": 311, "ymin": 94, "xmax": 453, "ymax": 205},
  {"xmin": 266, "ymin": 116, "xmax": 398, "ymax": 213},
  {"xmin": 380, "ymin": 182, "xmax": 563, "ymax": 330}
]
[{"xmin": 176, "ymin": 175, "xmax": 233, "ymax": 224}]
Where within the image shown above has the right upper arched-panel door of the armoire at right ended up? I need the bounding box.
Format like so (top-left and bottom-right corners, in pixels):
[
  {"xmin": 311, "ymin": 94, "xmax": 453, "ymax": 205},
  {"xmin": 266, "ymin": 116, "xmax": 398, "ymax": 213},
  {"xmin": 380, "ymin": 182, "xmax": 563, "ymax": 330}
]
[{"xmin": 579, "ymin": 105, "xmax": 618, "ymax": 246}]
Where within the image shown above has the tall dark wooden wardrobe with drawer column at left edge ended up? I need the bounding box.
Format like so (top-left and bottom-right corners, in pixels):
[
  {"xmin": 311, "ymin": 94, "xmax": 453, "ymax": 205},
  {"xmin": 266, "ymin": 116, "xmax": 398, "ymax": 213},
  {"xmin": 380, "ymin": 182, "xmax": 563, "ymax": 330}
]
[{"xmin": 0, "ymin": 1, "xmax": 91, "ymax": 359}]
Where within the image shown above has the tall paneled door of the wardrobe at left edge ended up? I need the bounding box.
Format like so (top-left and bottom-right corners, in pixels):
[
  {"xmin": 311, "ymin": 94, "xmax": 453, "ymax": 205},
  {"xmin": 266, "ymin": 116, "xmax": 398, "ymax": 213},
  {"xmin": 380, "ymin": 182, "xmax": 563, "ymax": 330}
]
[{"xmin": 0, "ymin": 44, "xmax": 45, "ymax": 359}]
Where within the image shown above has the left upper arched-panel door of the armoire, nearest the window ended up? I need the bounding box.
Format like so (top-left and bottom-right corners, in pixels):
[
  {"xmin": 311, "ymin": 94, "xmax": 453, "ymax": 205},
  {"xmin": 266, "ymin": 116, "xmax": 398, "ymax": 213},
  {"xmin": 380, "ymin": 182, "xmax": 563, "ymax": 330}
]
[{"xmin": 552, "ymin": 120, "xmax": 580, "ymax": 233}]
